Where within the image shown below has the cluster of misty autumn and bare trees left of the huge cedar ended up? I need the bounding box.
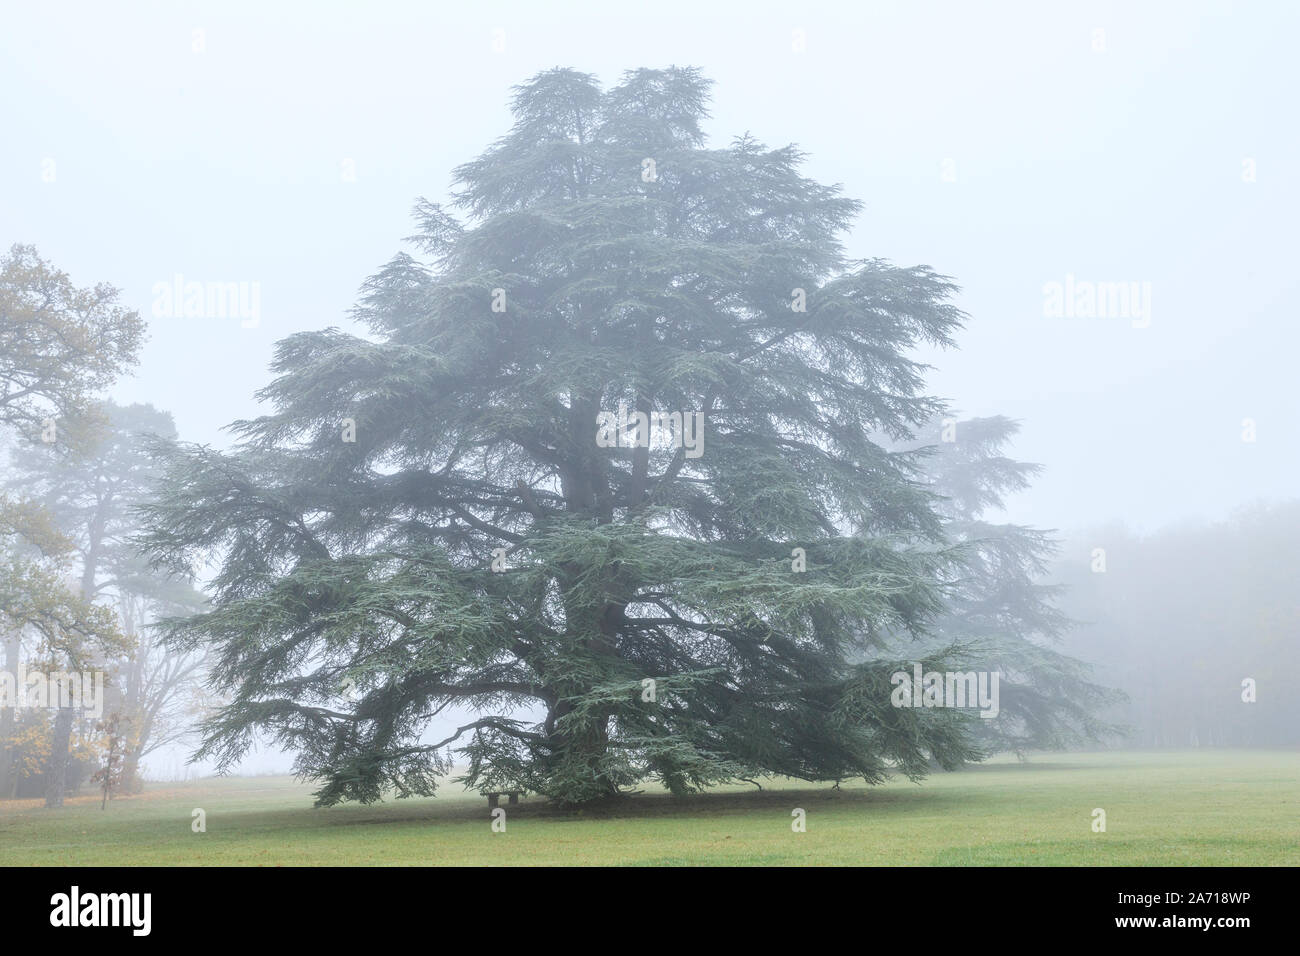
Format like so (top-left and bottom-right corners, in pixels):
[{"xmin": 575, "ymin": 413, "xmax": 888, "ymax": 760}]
[{"xmin": 0, "ymin": 246, "xmax": 202, "ymax": 806}]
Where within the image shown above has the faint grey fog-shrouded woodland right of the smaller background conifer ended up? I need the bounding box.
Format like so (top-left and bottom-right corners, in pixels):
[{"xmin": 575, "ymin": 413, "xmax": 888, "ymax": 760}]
[{"xmin": 1052, "ymin": 501, "xmax": 1300, "ymax": 748}]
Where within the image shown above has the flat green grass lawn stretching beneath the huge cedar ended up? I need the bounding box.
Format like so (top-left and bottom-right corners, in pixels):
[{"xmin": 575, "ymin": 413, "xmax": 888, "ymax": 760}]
[{"xmin": 0, "ymin": 750, "xmax": 1300, "ymax": 866}]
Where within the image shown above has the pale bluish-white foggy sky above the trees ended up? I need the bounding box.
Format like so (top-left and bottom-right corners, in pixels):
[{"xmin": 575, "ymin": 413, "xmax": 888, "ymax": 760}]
[{"xmin": 0, "ymin": 0, "xmax": 1300, "ymax": 775}]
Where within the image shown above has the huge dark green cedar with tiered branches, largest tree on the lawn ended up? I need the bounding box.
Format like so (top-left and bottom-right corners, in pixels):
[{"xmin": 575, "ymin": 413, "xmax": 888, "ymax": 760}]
[{"xmin": 143, "ymin": 63, "xmax": 998, "ymax": 804}]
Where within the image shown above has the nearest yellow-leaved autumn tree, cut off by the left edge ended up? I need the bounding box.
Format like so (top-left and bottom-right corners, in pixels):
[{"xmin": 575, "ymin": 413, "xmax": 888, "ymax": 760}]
[{"xmin": 0, "ymin": 245, "xmax": 144, "ymax": 806}]
